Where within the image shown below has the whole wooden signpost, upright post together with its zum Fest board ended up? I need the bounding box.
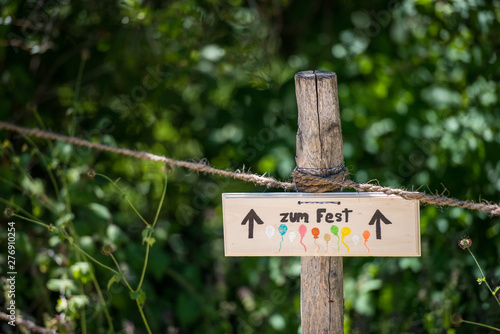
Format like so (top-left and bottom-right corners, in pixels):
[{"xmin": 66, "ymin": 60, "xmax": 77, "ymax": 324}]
[{"xmin": 222, "ymin": 71, "xmax": 420, "ymax": 334}]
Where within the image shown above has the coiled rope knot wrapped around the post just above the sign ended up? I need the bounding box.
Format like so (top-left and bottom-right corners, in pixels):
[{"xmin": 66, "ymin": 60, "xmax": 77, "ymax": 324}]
[{"xmin": 292, "ymin": 163, "xmax": 348, "ymax": 193}]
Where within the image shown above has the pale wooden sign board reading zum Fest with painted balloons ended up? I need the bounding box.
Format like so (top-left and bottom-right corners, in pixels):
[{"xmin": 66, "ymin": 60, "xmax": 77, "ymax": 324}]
[{"xmin": 222, "ymin": 193, "xmax": 420, "ymax": 256}]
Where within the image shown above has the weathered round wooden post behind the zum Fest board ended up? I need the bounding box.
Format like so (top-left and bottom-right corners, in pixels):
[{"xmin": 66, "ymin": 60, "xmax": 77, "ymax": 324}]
[{"xmin": 295, "ymin": 71, "xmax": 344, "ymax": 334}]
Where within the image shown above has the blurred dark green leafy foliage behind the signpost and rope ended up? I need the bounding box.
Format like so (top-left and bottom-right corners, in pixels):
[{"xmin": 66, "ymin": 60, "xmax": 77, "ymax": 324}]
[{"xmin": 0, "ymin": 0, "xmax": 500, "ymax": 333}]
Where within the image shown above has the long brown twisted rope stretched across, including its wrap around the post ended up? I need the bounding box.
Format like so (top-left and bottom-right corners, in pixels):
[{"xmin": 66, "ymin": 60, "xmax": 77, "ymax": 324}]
[{"xmin": 0, "ymin": 121, "xmax": 500, "ymax": 216}]
